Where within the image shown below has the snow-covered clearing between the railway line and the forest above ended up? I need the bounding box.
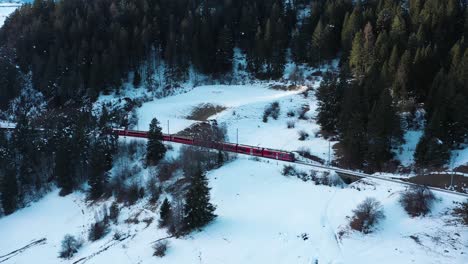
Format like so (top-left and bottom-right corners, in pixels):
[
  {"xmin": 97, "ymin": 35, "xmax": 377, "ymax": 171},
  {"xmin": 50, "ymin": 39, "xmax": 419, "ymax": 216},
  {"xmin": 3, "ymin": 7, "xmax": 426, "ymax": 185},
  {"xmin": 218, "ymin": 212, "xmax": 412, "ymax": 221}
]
[{"xmin": 104, "ymin": 83, "xmax": 333, "ymax": 160}]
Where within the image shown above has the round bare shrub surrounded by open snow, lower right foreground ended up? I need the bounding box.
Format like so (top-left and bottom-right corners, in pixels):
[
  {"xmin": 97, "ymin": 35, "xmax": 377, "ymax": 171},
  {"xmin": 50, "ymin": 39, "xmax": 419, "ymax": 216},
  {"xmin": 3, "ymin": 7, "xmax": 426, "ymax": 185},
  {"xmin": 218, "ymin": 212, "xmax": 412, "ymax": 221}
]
[{"xmin": 350, "ymin": 197, "xmax": 385, "ymax": 234}]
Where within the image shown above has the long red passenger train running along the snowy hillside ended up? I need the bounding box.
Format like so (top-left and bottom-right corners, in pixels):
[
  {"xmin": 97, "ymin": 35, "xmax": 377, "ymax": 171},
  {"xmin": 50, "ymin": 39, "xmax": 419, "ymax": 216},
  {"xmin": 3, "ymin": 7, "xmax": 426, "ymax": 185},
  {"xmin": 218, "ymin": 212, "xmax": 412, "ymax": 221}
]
[{"xmin": 114, "ymin": 129, "xmax": 295, "ymax": 162}]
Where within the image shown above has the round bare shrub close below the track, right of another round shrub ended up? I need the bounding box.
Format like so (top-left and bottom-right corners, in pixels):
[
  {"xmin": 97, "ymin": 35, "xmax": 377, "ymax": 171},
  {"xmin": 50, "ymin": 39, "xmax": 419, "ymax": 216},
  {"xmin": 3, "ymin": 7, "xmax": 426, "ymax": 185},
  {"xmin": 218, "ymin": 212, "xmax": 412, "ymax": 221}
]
[{"xmin": 400, "ymin": 185, "xmax": 435, "ymax": 217}]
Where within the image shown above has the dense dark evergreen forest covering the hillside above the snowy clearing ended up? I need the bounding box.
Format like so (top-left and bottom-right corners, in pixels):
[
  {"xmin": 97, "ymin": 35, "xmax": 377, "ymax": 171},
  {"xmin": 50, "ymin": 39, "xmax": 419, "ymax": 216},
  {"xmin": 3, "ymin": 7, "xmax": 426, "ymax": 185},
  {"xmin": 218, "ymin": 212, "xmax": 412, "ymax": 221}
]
[{"xmin": 0, "ymin": 0, "xmax": 468, "ymax": 213}]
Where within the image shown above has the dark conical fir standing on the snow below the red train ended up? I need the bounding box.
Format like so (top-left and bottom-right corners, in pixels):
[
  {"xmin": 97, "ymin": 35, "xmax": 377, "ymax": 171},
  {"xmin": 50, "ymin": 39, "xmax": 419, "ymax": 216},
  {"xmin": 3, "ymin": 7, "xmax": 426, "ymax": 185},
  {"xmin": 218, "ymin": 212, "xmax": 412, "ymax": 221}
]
[{"xmin": 183, "ymin": 167, "xmax": 216, "ymax": 232}]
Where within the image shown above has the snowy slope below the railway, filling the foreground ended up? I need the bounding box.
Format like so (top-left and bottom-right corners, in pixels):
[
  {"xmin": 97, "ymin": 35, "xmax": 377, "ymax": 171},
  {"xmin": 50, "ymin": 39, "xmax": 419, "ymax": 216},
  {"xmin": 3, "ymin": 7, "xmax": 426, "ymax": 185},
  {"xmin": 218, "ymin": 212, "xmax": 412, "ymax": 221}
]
[{"xmin": 0, "ymin": 156, "xmax": 468, "ymax": 264}]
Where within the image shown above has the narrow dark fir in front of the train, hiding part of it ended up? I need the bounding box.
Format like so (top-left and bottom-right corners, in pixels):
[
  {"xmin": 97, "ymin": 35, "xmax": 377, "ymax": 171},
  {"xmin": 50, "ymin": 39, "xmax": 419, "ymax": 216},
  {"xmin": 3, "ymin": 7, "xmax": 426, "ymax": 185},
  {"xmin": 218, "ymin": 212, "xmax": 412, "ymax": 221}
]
[{"xmin": 146, "ymin": 118, "xmax": 166, "ymax": 165}]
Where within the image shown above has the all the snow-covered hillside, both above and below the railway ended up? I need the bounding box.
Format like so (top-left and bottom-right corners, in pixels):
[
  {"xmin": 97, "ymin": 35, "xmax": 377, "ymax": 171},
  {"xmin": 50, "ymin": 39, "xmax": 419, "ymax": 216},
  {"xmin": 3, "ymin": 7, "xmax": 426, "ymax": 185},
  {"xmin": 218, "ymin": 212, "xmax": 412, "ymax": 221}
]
[{"xmin": 0, "ymin": 81, "xmax": 468, "ymax": 264}]
